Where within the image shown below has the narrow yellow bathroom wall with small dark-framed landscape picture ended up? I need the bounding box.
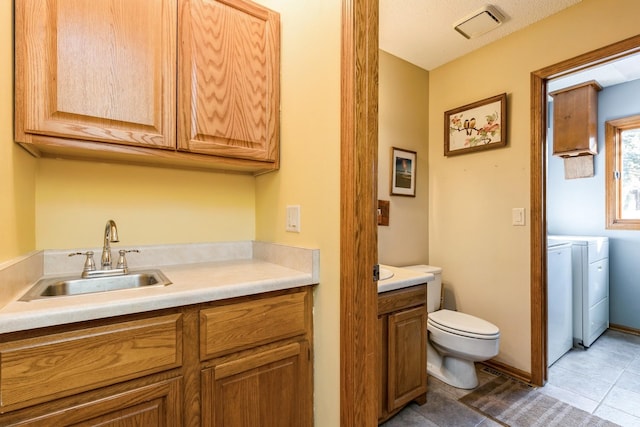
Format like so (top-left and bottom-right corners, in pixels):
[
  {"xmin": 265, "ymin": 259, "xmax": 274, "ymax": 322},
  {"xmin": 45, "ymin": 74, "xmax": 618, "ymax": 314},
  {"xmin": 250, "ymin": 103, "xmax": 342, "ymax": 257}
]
[{"xmin": 378, "ymin": 51, "xmax": 429, "ymax": 266}]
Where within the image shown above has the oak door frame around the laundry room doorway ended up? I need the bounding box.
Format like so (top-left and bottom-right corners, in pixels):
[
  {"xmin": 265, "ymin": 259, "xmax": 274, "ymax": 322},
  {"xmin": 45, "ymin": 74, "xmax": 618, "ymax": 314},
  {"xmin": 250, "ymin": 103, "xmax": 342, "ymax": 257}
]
[{"xmin": 531, "ymin": 36, "xmax": 640, "ymax": 385}]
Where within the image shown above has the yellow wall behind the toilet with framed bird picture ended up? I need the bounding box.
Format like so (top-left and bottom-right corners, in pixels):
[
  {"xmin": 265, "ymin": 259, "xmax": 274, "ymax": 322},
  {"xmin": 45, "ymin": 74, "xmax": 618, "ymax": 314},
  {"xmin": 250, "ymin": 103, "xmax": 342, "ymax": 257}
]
[{"xmin": 429, "ymin": 0, "xmax": 640, "ymax": 371}]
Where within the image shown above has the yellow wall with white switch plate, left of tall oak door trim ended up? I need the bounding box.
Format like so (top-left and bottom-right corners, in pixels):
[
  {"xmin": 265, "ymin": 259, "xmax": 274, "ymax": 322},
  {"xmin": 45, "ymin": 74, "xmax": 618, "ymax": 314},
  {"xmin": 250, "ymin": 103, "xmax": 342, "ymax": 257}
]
[{"xmin": 256, "ymin": 0, "xmax": 342, "ymax": 426}]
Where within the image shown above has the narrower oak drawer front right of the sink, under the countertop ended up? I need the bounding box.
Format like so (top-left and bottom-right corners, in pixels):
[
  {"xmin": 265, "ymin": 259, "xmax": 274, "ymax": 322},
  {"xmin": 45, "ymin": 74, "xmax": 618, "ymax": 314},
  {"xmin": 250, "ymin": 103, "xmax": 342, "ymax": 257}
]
[{"xmin": 200, "ymin": 291, "xmax": 311, "ymax": 360}]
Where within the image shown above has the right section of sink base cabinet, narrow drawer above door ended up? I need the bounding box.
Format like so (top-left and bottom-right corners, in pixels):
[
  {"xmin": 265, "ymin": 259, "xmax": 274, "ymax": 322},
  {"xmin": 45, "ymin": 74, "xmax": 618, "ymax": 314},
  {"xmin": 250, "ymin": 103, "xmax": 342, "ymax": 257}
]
[{"xmin": 200, "ymin": 292, "xmax": 313, "ymax": 427}]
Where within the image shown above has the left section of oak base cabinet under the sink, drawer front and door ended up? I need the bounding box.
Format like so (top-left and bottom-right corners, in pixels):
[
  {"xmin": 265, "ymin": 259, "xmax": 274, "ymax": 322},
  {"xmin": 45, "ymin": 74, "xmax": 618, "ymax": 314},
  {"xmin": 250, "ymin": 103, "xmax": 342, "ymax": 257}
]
[{"xmin": 0, "ymin": 313, "xmax": 183, "ymax": 426}]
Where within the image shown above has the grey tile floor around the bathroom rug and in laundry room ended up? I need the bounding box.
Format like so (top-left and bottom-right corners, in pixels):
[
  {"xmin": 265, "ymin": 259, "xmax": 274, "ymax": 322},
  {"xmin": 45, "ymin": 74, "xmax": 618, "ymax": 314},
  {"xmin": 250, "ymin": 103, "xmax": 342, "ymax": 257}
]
[{"xmin": 381, "ymin": 330, "xmax": 640, "ymax": 427}]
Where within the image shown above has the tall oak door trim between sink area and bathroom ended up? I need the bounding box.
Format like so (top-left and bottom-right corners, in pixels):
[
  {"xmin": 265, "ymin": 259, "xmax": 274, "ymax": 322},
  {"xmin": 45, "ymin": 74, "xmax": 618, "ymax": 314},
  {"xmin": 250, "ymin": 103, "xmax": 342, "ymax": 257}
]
[{"xmin": 340, "ymin": 0, "xmax": 379, "ymax": 427}]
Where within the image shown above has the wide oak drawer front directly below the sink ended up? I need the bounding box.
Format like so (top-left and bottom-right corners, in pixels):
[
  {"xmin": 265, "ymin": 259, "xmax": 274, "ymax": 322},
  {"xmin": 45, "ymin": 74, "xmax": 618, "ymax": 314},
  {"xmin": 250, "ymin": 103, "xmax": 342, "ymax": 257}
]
[{"xmin": 0, "ymin": 314, "xmax": 182, "ymax": 412}]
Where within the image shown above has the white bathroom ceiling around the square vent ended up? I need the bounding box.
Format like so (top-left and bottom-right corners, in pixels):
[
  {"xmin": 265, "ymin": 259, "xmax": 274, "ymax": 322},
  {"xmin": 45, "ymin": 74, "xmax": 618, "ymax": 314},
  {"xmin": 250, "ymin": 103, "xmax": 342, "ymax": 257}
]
[{"xmin": 380, "ymin": 0, "xmax": 581, "ymax": 70}]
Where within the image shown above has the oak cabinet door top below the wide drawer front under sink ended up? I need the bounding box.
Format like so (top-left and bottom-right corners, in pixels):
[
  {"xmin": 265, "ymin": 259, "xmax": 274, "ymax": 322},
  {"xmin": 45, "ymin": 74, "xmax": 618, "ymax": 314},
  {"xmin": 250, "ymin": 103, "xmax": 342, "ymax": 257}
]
[{"xmin": 0, "ymin": 378, "xmax": 183, "ymax": 427}]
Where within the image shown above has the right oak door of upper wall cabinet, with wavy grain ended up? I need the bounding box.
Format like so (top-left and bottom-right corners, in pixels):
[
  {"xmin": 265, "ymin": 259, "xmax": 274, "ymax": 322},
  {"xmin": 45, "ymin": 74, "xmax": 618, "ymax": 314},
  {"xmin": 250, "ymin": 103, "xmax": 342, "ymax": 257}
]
[{"xmin": 178, "ymin": 0, "xmax": 280, "ymax": 163}]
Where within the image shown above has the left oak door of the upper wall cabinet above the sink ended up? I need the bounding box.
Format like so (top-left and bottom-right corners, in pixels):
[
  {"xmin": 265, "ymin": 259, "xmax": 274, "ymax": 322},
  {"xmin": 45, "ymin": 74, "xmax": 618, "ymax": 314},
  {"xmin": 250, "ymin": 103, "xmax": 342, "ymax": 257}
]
[{"xmin": 15, "ymin": 0, "xmax": 177, "ymax": 149}]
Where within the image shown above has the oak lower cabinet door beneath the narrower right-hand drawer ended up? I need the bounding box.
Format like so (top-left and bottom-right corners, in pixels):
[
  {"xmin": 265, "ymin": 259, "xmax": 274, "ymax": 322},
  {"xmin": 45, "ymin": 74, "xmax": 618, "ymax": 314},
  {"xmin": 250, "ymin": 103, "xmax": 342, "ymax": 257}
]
[{"xmin": 201, "ymin": 341, "xmax": 312, "ymax": 427}]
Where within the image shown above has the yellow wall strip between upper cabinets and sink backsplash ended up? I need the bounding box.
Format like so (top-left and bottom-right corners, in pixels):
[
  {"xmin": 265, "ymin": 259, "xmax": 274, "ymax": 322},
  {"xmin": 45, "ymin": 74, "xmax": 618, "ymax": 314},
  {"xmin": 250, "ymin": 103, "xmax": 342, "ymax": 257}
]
[{"xmin": 36, "ymin": 159, "xmax": 255, "ymax": 249}]
